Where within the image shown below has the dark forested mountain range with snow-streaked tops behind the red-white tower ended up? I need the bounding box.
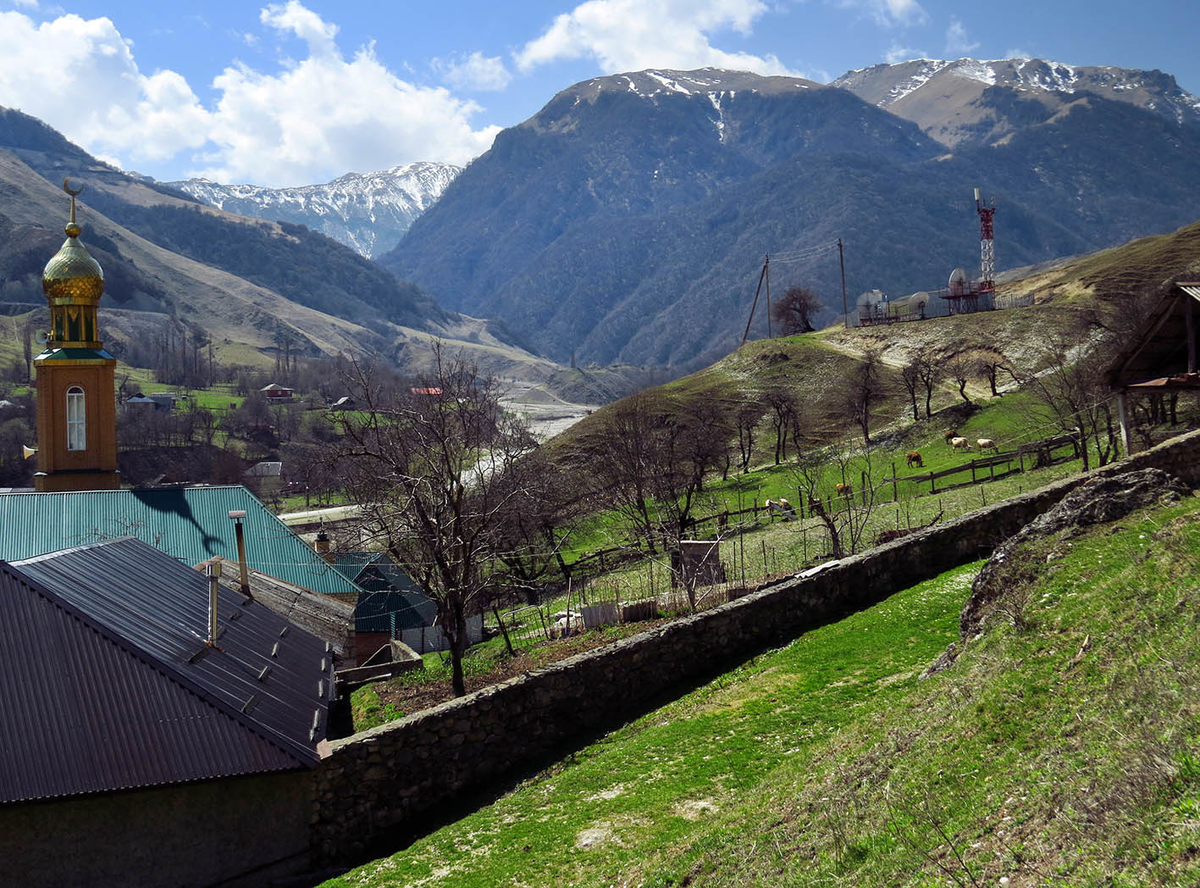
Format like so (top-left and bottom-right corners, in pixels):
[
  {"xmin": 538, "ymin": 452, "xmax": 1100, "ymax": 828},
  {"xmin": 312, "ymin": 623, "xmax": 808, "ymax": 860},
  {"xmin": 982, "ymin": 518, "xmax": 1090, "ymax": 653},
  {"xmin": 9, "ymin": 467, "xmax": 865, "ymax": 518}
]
[{"xmin": 379, "ymin": 60, "xmax": 1200, "ymax": 370}]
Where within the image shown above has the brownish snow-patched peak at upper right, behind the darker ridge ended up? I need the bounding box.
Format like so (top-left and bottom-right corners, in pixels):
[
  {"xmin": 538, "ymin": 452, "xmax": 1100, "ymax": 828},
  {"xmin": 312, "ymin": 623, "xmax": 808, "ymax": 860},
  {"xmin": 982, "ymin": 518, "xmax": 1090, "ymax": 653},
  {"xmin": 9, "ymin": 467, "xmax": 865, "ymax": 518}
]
[{"xmin": 829, "ymin": 59, "xmax": 1200, "ymax": 146}]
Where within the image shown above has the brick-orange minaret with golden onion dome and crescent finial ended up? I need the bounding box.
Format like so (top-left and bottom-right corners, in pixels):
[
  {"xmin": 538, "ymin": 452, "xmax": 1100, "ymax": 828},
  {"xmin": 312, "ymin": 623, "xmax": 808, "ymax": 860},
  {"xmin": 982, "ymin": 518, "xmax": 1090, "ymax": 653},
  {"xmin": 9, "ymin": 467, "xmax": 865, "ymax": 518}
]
[{"xmin": 34, "ymin": 179, "xmax": 121, "ymax": 491}]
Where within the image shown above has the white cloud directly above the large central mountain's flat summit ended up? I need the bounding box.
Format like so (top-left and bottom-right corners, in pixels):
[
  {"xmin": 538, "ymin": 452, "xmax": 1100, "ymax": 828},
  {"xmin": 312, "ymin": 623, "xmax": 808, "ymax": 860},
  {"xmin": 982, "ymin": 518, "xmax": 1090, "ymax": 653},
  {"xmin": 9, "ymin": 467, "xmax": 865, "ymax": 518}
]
[{"xmin": 515, "ymin": 0, "xmax": 796, "ymax": 74}]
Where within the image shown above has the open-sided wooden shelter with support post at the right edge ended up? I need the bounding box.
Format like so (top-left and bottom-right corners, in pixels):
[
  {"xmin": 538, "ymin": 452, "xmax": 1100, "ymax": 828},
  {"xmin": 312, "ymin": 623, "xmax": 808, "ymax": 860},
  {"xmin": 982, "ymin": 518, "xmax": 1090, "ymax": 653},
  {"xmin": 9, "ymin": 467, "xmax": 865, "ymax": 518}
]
[{"xmin": 1106, "ymin": 282, "xmax": 1200, "ymax": 454}]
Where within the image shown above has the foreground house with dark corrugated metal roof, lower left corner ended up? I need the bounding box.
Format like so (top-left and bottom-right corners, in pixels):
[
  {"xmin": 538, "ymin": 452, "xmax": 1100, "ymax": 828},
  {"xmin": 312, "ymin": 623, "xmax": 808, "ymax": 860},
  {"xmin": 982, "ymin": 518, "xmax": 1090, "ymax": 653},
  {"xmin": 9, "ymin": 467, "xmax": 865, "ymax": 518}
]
[{"xmin": 0, "ymin": 539, "xmax": 334, "ymax": 888}]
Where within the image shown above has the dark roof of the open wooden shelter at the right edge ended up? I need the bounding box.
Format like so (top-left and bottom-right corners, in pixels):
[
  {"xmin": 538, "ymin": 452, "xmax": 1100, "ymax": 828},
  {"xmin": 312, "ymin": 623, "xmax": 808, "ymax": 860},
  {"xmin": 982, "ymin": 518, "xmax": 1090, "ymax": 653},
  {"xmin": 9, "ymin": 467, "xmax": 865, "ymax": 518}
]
[{"xmin": 1108, "ymin": 283, "xmax": 1200, "ymax": 389}]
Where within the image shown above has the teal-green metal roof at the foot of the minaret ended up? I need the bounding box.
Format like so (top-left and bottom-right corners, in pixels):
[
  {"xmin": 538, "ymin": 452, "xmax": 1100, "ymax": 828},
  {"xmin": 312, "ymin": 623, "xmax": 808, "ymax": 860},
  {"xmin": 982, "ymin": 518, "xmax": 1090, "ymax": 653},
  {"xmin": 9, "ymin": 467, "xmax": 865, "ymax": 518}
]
[{"xmin": 0, "ymin": 486, "xmax": 359, "ymax": 594}]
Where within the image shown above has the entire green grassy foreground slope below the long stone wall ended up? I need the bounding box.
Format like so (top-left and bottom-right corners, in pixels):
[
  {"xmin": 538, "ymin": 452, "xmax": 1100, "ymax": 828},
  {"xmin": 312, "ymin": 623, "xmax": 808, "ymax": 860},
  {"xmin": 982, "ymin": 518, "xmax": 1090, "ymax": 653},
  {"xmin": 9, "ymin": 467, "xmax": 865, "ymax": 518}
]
[{"xmin": 328, "ymin": 498, "xmax": 1200, "ymax": 888}]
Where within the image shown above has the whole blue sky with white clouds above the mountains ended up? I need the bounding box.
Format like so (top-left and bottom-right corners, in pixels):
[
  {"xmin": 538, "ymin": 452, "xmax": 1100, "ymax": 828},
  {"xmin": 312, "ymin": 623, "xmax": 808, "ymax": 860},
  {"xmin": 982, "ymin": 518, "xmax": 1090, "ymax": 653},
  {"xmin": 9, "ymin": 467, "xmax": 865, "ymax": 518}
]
[{"xmin": 0, "ymin": 0, "xmax": 1200, "ymax": 187}]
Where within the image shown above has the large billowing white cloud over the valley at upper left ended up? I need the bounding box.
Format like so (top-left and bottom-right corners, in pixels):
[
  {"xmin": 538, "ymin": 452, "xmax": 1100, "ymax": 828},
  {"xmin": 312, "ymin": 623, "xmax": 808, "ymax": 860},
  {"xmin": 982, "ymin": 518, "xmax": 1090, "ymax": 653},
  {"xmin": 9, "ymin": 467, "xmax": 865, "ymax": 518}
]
[{"xmin": 0, "ymin": 0, "xmax": 499, "ymax": 185}]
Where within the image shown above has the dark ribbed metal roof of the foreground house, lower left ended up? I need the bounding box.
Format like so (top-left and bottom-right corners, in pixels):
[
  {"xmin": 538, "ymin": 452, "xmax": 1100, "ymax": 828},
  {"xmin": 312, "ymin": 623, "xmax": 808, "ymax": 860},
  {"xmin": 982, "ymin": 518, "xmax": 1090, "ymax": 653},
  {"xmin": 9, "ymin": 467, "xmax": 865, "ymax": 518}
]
[{"xmin": 0, "ymin": 539, "xmax": 334, "ymax": 803}]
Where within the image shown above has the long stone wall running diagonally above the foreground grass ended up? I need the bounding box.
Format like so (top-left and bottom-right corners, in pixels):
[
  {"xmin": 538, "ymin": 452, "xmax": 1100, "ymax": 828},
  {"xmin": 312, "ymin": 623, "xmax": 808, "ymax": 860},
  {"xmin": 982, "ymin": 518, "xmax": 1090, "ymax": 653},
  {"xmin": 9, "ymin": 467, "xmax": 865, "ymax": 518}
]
[{"xmin": 312, "ymin": 432, "xmax": 1200, "ymax": 864}]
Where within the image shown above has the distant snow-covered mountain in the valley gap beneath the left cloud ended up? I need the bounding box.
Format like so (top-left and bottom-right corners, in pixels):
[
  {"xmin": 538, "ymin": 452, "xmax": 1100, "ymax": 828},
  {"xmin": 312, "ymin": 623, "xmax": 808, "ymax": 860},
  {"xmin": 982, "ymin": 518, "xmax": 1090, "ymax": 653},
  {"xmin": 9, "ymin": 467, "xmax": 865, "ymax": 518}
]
[{"xmin": 167, "ymin": 162, "xmax": 462, "ymax": 259}]
